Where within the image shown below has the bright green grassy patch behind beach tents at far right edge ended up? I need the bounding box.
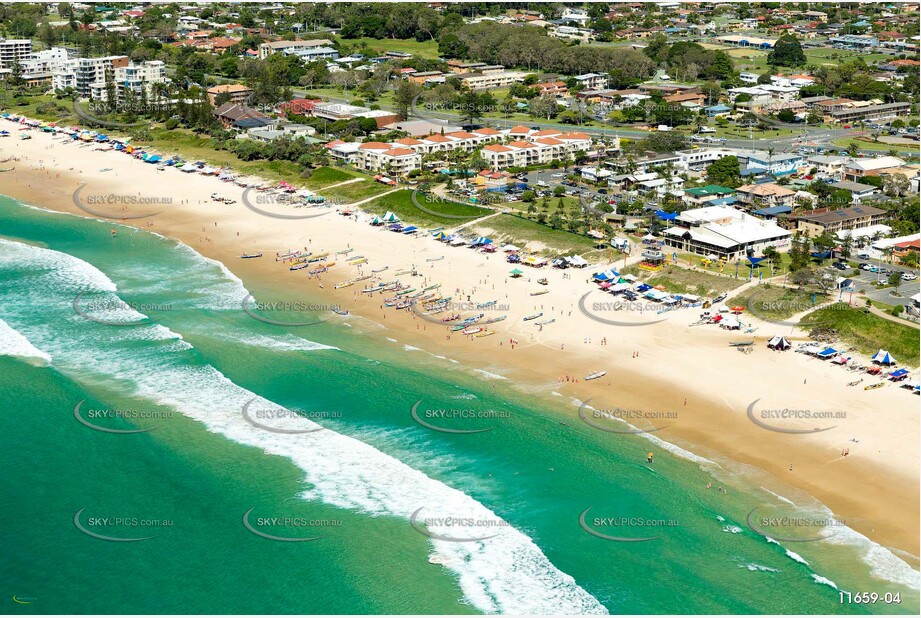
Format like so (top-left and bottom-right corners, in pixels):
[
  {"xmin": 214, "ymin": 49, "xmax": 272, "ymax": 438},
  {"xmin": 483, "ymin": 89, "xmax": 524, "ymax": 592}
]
[{"xmin": 807, "ymin": 305, "xmax": 919, "ymax": 367}]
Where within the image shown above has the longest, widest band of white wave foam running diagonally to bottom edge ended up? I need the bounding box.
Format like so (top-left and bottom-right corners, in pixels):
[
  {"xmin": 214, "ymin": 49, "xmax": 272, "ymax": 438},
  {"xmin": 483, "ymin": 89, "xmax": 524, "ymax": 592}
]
[{"xmin": 0, "ymin": 236, "xmax": 607, "ymax": 614}]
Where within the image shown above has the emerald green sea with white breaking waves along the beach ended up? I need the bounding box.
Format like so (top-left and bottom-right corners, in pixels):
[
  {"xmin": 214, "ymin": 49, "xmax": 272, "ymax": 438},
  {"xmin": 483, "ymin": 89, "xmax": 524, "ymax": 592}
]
[{"xmin": 0, "ymin": 197, "xmax": 918, "ymax": 614}]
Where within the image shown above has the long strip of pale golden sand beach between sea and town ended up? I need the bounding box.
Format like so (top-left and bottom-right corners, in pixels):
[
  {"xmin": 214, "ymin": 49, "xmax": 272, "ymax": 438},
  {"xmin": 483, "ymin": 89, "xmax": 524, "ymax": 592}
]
[{"xmin": 0, "ymin": 129, "xmax": 919, "ymax": 567}]
